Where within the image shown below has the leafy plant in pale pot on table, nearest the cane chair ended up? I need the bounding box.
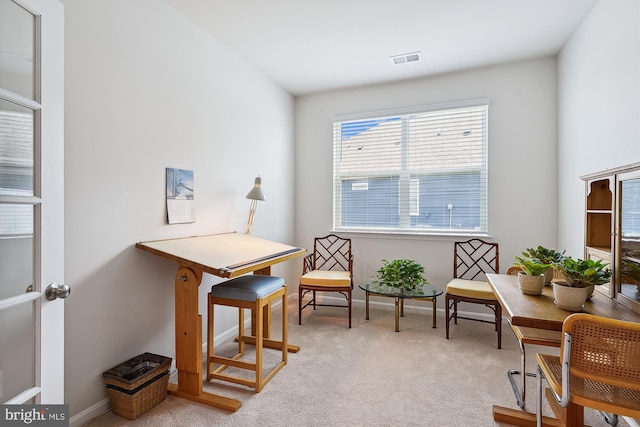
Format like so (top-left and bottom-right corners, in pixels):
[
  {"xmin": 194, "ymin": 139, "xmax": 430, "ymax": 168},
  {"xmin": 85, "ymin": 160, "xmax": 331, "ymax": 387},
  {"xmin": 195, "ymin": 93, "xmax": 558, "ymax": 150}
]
[{"xmin": 553, "ymin": 257, "xmax": 611, "ymax": 311}]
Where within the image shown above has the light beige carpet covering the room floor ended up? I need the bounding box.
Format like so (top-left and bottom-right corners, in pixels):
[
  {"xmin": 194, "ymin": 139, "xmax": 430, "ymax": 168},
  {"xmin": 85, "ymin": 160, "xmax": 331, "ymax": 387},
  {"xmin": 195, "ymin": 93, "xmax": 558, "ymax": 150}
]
[{"xmin": 86, "ymin": 298, "xmax": 628, "ymax": 427}]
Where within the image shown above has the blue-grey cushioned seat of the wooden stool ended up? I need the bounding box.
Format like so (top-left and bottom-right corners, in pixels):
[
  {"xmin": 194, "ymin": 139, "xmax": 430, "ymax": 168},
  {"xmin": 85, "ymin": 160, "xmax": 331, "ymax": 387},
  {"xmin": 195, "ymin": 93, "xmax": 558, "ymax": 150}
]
[{"xmin": 211, "ymin": 274, "xmax": 284, "ymax": 301}]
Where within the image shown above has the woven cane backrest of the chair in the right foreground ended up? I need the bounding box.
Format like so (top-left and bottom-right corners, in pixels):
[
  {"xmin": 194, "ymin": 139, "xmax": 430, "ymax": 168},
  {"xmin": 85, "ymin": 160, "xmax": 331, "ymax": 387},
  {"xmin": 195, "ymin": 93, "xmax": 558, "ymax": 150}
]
[{"xmin": 560, "ymin": 313, "xmax": 640, "ymax": 390}]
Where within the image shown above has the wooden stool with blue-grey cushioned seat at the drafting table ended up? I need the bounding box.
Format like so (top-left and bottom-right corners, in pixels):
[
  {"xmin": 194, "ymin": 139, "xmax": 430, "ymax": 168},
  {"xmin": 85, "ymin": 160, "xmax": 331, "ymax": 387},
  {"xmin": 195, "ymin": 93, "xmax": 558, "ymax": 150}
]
[{"xmin": 207, "ymin": 275, "xmax": 287, "ymax": 393}]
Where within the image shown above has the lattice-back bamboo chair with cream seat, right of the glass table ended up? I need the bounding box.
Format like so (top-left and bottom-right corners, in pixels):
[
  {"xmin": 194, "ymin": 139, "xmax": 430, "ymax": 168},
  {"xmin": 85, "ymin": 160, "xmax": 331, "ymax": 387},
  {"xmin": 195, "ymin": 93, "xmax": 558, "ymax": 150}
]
[{"xmin": 445, "ymin": 239, "xmax": 502, "ymax": 348}]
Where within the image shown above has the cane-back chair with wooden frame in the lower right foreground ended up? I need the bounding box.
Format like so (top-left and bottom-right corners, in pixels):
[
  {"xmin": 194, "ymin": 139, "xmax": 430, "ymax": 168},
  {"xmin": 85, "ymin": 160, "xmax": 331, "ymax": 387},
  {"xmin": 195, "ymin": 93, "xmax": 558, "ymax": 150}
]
[{"xmin": 536, "ymin": 313, "xmax": 640, "ymax": 426}]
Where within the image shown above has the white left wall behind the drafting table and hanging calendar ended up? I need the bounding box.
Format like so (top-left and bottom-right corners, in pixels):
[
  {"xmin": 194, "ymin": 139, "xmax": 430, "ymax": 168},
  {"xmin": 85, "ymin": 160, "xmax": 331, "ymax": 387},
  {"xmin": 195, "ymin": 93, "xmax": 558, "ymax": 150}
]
[{"xmin": 64, "ymin": 0, "xmax": 301, "ymax": 422}]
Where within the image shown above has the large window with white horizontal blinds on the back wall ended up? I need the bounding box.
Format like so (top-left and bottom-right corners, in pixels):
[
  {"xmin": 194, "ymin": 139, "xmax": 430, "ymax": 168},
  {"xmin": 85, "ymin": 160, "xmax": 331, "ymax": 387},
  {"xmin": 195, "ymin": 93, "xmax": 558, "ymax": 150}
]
[{"xmin": 333, "ymin": 100, "xmax": 488, "ymax": 234}]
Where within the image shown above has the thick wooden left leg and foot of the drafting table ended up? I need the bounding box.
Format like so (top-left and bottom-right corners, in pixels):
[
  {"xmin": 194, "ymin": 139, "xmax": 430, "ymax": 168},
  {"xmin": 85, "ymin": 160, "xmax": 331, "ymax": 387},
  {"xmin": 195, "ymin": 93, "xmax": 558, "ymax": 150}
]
[{"xmin": 169, "ymin": 265, "xmax": 242, "ymax": 412}]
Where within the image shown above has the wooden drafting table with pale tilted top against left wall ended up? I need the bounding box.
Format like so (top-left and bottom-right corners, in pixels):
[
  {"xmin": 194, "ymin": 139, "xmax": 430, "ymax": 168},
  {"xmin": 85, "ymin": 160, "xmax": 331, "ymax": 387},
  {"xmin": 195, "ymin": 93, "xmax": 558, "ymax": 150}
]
[{"xmin": 136, "ymin": 233, "xmax": 306, "ymax": 412}]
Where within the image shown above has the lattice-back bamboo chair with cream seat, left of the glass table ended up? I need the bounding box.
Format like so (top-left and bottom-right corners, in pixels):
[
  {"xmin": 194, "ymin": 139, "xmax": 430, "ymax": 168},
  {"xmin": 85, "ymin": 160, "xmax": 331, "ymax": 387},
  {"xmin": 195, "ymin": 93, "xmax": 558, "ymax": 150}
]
[{"xmin": 298, "ymin": 234, "xmax": 353, "ymax": 328}]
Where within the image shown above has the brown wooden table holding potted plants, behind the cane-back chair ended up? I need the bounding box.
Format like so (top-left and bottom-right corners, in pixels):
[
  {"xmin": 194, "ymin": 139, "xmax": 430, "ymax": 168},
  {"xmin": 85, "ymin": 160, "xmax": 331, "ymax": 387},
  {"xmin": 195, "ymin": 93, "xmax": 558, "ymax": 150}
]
[{"xmin": 487, "ymin": 274, "xmax": 640, "ymax": 427}]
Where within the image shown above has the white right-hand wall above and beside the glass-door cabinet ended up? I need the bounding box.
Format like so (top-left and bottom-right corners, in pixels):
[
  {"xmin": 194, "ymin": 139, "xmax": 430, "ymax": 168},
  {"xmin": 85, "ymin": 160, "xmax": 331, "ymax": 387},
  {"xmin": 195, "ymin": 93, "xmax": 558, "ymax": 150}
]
[{"xmin": 558, "ymin": 0, "xmax": 640, "ymax": 257}]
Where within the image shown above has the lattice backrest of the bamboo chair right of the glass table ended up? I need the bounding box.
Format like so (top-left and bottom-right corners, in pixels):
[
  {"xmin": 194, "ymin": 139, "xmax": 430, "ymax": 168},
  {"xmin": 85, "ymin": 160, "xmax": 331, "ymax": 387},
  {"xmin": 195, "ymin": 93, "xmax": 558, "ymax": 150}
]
[{"xmin": 453, "ymin": 239, "xmax": 500, "ymax": 280}]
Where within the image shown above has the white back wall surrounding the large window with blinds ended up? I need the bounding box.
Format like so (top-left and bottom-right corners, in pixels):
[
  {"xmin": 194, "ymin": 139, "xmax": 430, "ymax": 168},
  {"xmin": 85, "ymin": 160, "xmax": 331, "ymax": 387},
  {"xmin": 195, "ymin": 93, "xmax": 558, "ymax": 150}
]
[{"xmin": 296, "ymin": 58, "xmax": 557, "ymax": 298}]
